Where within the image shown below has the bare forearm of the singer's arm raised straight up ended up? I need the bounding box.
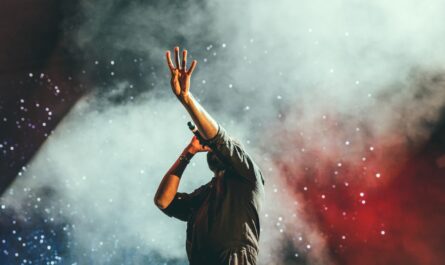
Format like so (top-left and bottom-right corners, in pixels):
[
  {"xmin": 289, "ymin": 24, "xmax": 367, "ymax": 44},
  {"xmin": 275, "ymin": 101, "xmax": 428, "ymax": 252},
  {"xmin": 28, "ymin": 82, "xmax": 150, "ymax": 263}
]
[{"xmin": 181, "ymin": 93, "xmax": 218, "ymax": 140}]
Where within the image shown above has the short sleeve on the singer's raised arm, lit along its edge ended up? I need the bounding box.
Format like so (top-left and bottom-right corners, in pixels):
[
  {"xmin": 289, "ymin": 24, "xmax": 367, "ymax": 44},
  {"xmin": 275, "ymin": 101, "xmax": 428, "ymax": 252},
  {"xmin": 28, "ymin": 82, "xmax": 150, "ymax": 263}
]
[{"xmin": 208, "ymin": 124, "xmax": 264, "ymax": 185}]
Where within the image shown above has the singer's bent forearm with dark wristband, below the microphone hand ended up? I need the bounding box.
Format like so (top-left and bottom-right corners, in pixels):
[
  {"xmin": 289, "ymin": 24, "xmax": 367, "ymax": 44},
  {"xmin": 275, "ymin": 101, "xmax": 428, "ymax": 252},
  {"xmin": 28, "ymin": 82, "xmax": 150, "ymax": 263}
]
[{"xmin": 154, "ymin": 148, "xmax": 194, "ymax": 208}]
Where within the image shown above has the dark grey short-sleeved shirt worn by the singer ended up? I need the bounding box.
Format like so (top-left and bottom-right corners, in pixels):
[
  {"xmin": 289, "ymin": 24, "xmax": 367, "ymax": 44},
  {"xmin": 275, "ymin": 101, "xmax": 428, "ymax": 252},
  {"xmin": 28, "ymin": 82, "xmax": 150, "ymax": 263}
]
[{"xmin": 162, "ymin": 125, "xmax": 264, "ymax": 265}]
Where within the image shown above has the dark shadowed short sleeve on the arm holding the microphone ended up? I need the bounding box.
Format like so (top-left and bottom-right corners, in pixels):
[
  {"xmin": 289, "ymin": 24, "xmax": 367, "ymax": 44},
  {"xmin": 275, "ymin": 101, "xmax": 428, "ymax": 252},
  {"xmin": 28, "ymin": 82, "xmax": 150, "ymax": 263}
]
[{"xmin": 160, "ymin": 184, "xmax": 208, "ymax": 222}]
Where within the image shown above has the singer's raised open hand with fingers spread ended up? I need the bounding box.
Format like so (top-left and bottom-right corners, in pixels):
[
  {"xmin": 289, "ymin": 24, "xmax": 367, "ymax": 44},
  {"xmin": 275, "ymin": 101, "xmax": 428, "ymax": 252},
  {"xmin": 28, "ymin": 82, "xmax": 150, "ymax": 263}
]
[{"xmin": 166, "ymin": 47, "xmax": 197, "ymax": 103}]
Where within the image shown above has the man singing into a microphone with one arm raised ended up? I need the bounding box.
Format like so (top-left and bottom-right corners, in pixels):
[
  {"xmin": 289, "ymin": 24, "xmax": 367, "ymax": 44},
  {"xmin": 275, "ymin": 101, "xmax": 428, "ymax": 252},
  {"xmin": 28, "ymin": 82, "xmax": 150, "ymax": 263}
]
[{"xmin": 154, "ymin": 47, "xmax": 264, "ymax": 265}]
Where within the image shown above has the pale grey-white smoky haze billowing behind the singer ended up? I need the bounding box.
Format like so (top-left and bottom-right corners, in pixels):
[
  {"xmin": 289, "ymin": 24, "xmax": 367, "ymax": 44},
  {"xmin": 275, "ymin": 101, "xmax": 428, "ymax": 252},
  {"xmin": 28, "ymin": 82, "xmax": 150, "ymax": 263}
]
[{"xmin": 1, "ymin": 0, "xmax": 445, "ymax": 264}]
